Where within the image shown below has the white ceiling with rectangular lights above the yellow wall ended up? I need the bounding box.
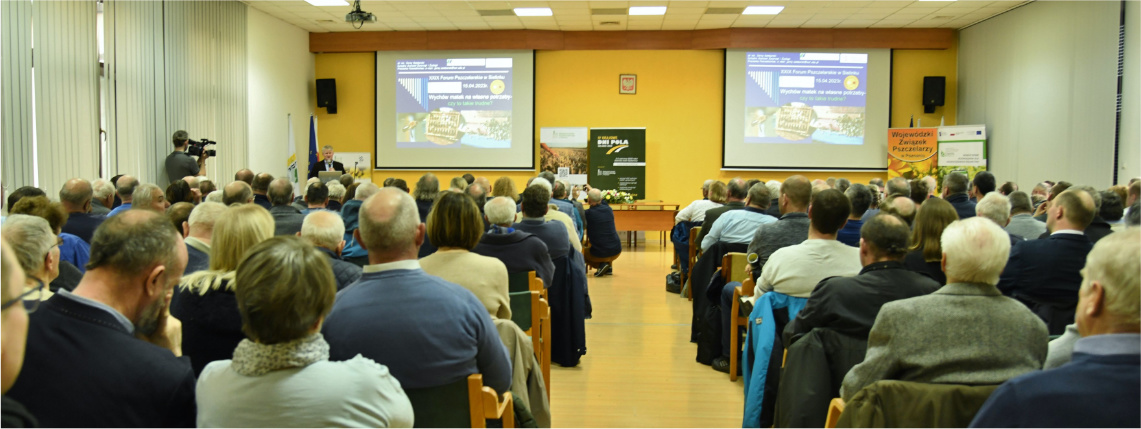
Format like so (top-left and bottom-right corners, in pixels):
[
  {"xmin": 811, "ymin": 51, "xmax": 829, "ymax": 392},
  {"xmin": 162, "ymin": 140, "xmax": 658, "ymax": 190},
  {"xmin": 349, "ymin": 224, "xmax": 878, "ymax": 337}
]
[{"xmin": 244, "ymin": 0, "xmax": 1027, "ymax": 33}]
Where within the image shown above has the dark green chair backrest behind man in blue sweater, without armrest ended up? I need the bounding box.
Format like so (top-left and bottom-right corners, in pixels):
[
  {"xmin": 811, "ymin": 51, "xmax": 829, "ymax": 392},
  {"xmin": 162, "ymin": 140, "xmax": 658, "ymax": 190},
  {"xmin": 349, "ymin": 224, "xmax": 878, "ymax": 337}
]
[{"xmin": 404, "ymin": 378, "xmax": 472, "ymax": 428}]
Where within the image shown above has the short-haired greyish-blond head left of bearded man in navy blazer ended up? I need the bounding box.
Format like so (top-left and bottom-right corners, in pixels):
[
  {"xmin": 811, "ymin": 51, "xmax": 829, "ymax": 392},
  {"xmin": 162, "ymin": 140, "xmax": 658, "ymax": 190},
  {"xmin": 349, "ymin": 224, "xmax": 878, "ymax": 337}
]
[{"xmin": 0, "ymin": 215, "xmax": 60, "ymax": 300}]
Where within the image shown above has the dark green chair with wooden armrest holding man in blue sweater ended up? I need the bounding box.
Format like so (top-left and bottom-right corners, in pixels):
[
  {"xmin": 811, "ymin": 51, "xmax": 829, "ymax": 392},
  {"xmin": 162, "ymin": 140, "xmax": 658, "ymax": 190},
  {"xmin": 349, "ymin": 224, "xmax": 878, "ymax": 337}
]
[{"xmin": 404, "ymin": 374, "xmax": 515, "ymax": 428}]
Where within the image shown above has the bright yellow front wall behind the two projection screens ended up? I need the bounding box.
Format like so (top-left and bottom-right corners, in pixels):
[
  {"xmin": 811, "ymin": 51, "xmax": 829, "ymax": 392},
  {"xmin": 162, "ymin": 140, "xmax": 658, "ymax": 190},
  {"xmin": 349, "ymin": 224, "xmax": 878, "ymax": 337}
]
[{"xmin": 302, "ymin": 44, "xmax": 956, "ymax": 204}]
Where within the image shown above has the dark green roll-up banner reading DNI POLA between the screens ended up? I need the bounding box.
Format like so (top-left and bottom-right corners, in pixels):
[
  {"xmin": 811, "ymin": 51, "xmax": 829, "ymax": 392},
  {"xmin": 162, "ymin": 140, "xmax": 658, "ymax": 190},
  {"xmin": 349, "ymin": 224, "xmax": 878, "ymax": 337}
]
[{"xmin": 589, "ymin": 128, "xmax": 646, "ymax": 200}]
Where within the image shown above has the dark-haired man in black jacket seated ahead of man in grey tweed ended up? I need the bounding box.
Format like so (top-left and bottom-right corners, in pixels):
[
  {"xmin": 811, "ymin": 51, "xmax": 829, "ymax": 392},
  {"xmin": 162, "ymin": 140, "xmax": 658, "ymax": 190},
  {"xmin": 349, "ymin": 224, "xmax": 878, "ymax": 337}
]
[{"xmin": 784, "ymin": 215, "xmax": 940, "ymax": 346}]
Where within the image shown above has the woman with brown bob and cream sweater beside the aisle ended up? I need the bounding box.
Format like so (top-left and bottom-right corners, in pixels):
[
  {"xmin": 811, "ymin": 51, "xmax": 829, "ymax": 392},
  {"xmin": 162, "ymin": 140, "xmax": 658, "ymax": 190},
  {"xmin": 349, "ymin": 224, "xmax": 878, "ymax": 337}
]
[{"xmin": 420, "ymin": 192, "xmax": 511, "ymax": 318}]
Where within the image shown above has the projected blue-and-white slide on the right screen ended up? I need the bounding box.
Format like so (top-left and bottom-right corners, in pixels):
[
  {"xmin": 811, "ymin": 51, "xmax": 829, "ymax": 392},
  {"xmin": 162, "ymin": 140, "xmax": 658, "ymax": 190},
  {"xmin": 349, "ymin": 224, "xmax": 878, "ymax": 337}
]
[{"xmin": 744, "ymin": 52, "xmax": 867, "ymax": 145}]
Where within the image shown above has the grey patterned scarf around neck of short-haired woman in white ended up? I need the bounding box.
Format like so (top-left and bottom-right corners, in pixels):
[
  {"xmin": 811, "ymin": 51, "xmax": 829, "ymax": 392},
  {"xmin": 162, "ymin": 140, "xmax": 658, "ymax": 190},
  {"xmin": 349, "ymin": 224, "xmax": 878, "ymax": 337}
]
[{"xmin": 230, "ymin": 333, "xmax": 329, "ymax": 377}]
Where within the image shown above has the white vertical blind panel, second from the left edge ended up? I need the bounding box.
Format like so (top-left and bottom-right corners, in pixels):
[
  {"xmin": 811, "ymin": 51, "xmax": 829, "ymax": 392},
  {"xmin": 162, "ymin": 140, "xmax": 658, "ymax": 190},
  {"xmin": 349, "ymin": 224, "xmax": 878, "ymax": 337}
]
[{"xmin": 32, "ymin": 0, "xmax": 99, "ymax": 196}]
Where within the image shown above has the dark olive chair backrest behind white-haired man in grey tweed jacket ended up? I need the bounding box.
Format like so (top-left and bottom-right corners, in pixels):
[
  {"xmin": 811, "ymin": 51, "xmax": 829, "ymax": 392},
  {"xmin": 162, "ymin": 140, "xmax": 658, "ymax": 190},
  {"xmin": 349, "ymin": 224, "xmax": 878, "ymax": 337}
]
[{"xmin": 836, "ymin": 380, "xmax": 998, "ymax": 428}]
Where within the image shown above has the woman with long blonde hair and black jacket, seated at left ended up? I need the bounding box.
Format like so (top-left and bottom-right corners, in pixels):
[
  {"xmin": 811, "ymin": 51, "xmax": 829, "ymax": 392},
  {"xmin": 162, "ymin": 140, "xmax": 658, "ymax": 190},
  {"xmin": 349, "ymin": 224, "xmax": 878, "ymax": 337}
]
[{"xmin": 170, "ymin": 204, "xmax": 274, "ymax": 375}]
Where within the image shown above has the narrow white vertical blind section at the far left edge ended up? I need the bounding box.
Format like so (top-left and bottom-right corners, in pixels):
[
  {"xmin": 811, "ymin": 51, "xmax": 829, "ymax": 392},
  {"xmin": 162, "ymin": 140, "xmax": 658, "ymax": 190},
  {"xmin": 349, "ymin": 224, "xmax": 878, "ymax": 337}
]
[{"xmin": 0, "ymin": 0, "xmax": 34, "ymax": 190}]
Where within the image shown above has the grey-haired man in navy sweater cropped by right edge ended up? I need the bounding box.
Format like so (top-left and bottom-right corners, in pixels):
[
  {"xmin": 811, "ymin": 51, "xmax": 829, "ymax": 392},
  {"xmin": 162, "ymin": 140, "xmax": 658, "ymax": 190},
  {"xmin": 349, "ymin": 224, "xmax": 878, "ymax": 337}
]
[{"xmin": 971, "ymin": 228, "xmax": 1141, "ymax": 428}]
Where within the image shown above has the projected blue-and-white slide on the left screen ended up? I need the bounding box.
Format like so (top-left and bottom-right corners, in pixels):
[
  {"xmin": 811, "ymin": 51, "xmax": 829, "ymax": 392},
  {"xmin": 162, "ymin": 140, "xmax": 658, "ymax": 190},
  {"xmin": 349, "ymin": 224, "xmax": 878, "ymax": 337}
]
[{"xmin": 395, "ymin": 58, "xmax": 512, "ymax": 148}]
